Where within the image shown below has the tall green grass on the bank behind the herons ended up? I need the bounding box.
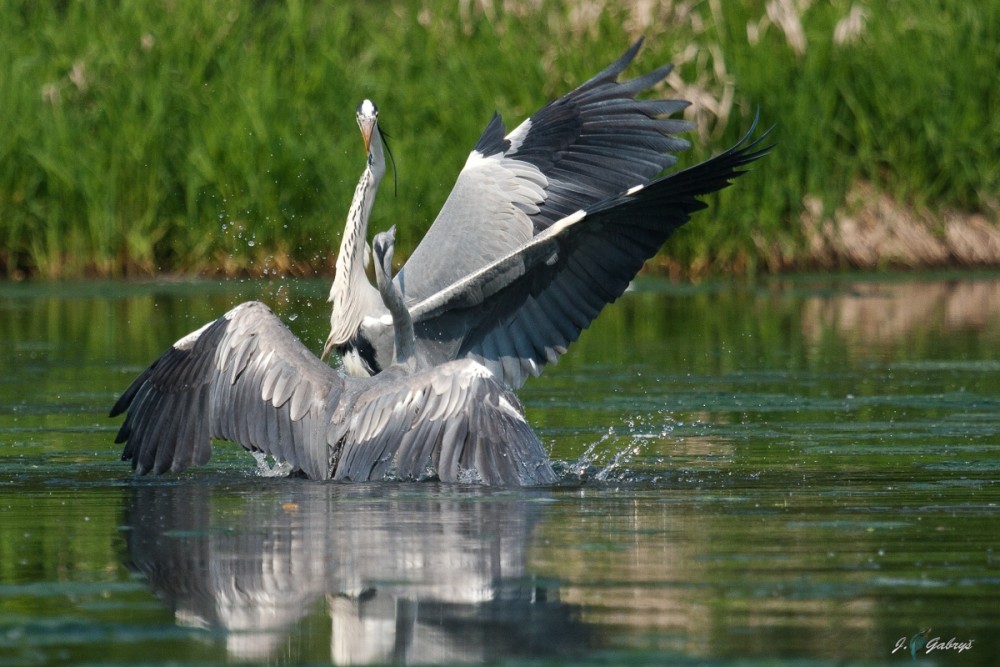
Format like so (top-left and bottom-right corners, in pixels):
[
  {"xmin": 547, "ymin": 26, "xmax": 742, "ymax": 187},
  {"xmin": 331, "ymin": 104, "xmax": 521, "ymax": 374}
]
[{"xmin": 0, "ymin": 0, "xmax": 1000, "ymax": 276}]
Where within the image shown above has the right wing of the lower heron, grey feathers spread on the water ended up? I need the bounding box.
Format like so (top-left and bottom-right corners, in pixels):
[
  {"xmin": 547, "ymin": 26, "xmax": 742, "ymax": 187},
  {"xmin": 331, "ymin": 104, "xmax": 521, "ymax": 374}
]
[{"xmin": 331, "ymin": 366, "xmax": 556, "ymax": 486}]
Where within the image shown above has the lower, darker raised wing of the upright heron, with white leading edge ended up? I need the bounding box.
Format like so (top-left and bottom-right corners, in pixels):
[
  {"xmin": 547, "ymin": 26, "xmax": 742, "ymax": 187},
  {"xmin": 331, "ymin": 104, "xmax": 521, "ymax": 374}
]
[{"xmin": 410, "ymin": 121, "xmax": 770, "ymax": 387}]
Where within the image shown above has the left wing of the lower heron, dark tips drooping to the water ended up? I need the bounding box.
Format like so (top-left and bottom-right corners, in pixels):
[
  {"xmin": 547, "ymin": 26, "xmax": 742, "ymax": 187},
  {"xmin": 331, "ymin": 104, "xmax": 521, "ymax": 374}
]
[{"xmin": 111, "ymin": 302, "xmax": 343, "ymax": 479}]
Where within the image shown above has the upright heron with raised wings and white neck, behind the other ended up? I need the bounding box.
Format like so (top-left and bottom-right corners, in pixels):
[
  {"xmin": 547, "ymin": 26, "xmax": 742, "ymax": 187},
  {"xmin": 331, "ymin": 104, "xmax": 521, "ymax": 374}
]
[{"xmin": 324, "ymin": 40, "xmax": 768, "ymax": 388}]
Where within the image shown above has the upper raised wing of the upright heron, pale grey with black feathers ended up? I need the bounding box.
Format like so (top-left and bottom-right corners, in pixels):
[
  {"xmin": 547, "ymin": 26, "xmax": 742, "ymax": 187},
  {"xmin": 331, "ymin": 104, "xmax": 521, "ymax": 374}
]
[{"xmin": 396, "ymin": 40, "xmax": 692, "ymax": 302}]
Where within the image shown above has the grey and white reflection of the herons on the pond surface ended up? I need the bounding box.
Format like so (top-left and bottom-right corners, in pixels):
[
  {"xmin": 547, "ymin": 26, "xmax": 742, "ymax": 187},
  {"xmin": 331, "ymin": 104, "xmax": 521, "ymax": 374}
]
[{"xmin": 123, "ymin": 480, "xmax": 590, "ymax": 664}]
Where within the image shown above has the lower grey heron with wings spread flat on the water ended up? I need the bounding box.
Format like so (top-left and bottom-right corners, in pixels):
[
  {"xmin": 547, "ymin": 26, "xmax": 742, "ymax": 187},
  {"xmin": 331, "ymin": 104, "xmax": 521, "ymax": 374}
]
[{"xmin": 111, "ymin": 226, "xmax": 556, "ymax": 485}]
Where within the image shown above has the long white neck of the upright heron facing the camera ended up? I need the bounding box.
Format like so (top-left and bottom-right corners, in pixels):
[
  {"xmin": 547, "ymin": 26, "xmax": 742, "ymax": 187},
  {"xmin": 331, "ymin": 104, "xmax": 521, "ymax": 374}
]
[{"xmin": 327, "ymin": 129, "xmax": 385, "ymax": 350}]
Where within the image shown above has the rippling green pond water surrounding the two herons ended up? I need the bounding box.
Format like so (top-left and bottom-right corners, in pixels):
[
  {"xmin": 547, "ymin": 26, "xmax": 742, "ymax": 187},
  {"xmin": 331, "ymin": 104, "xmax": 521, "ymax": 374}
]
[{"xmin": 0, "ymin": 274, "xmax": 1000, "ymax": 665}]
